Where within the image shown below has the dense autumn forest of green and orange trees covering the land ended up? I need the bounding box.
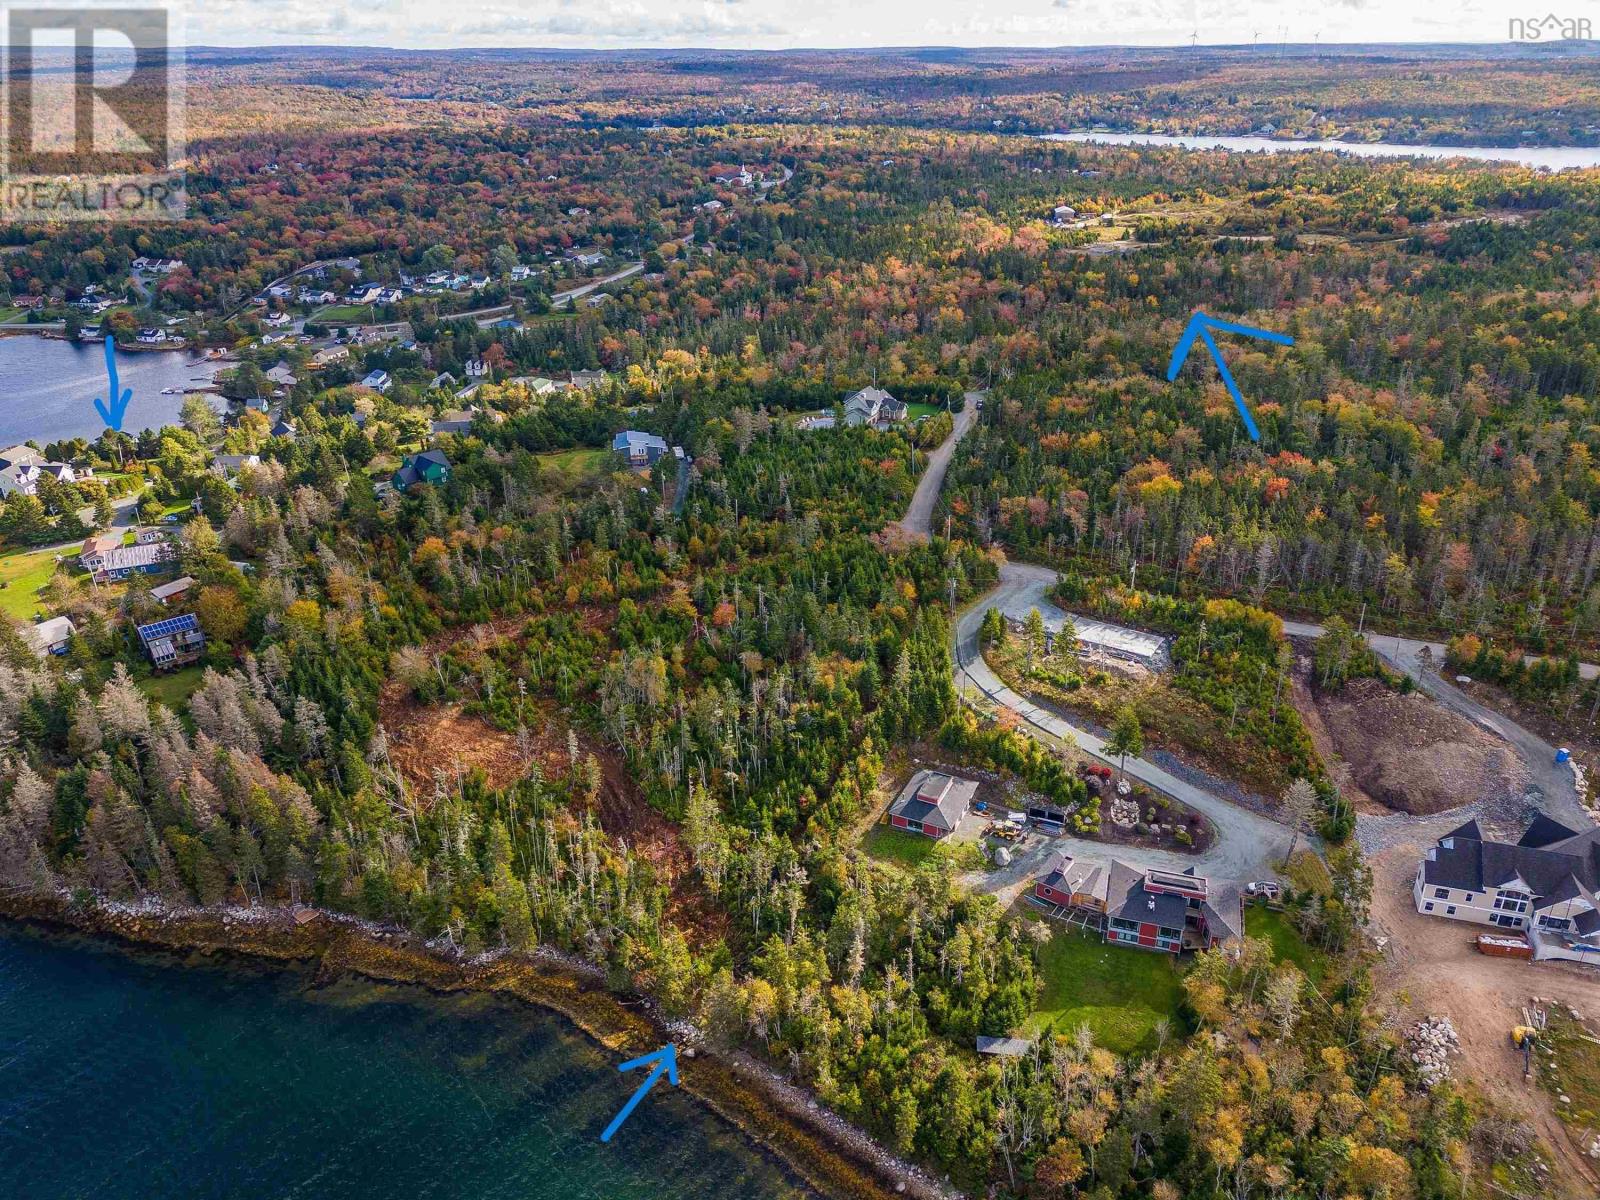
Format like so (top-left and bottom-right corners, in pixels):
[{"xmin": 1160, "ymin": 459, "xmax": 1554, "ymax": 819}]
[{"xmin": 0, "ymin": 56, "xmax": 1600, "ymax": 1200}]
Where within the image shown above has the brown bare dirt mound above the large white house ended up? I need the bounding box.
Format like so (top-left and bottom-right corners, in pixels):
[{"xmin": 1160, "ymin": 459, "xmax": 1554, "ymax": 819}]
[{"xmin": 1310, "ymin": 678, "xmax": 1526, "ymax": 813}]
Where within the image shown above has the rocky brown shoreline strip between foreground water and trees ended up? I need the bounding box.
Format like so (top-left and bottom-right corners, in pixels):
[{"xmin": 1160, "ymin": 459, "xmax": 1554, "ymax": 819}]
[{"xmin": 0, "ymin": 894, "xmax": 963, "ymax": 1200}]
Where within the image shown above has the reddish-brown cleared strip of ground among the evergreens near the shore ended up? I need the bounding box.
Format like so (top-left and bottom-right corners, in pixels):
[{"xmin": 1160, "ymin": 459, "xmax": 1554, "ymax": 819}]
[{"xmin": 378, "ymin": 618, "xmax": 730, "ymax": 947}]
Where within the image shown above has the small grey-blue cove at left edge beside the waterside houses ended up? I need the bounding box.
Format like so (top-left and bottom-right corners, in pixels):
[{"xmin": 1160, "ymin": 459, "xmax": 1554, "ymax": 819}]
[{"xmin": 0, "ymin": 334, "xmax": 219, "ymax": 446}]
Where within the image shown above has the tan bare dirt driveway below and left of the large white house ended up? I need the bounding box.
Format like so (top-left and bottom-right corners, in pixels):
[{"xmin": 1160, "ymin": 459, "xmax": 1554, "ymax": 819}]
[{"xmin": 1371, "ymin": 840, "xmax": 1600, "ymax": 1197}]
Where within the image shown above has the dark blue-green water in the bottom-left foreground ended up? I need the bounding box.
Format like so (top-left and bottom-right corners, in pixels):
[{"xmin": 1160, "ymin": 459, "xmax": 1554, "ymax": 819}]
[{"xmin": 0, "ymin": 923, "xmax": 813, "ymax": 1200}]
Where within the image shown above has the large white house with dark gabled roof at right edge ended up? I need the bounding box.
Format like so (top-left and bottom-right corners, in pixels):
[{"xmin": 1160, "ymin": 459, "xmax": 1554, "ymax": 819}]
[{"xmin": 1411, "ymin": 814, "xmax": 1600, "ymax": 965}]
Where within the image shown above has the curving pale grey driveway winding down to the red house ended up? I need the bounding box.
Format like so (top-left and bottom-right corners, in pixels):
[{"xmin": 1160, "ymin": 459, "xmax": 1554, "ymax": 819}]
[{"xmin": 955, "ymin": 563, "xmax": 1304, "ymax": 886}]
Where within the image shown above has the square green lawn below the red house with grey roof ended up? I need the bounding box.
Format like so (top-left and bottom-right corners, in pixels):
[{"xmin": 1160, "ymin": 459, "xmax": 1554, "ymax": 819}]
[{"xmin": 1027, "ymin": 917, "xmax": 1182, "ymax": 1054}]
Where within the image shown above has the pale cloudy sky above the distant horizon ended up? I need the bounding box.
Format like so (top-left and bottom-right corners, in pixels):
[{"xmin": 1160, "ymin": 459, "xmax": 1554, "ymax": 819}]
[{"xmin": 187, "ymin": 0, "xmax": 1523, "ymax": 50}]
